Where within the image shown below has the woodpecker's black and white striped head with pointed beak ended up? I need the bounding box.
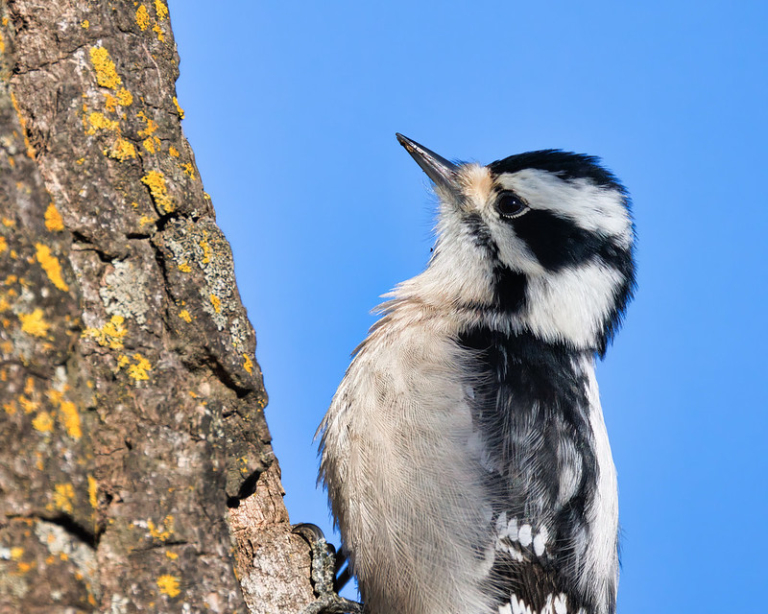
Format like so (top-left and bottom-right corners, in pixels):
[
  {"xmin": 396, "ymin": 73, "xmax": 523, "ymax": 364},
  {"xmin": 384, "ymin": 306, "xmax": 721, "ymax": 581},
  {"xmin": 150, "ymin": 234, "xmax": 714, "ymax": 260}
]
[{"xmin": 395, "ymin": 134, "xmax": 635, "ymax": 355}]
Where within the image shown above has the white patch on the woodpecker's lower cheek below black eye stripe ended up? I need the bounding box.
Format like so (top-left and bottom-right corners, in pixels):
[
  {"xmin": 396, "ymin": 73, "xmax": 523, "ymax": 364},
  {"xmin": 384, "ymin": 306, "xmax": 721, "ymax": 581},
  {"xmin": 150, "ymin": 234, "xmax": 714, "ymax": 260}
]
[{"xmin": 523, "ymin": 263, "xmax": 623, "ymax": 347}]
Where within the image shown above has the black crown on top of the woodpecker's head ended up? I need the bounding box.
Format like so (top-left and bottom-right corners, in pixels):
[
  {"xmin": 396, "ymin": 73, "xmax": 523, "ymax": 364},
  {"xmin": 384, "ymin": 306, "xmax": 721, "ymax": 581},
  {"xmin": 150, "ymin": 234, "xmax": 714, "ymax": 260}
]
[{"xmin": 488, "ymin": 149, "xmax": 626, "ymax": 194}]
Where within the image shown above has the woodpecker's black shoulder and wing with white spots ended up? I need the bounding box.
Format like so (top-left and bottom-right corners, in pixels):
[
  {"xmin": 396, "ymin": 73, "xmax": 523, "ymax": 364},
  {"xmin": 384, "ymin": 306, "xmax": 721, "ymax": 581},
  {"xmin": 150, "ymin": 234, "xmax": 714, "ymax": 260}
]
[{"xmin": 462, "ymin": 330, "xmax": 596, "ymax": 614}]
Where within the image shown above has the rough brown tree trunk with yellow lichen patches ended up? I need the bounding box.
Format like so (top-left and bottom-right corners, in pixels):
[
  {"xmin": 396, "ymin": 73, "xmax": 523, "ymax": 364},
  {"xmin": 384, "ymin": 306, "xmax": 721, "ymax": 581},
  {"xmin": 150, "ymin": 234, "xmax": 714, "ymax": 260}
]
[{"xmin": 0, "ymin": 0, "xmax": 312, "ymax": 614}]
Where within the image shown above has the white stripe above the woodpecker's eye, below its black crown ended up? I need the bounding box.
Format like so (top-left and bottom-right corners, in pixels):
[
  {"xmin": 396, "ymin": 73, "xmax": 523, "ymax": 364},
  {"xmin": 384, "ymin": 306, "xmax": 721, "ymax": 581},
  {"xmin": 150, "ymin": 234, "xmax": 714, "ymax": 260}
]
[{"xmin": 498, "ymin": 169, "xmax": 632, "ymax": 247}]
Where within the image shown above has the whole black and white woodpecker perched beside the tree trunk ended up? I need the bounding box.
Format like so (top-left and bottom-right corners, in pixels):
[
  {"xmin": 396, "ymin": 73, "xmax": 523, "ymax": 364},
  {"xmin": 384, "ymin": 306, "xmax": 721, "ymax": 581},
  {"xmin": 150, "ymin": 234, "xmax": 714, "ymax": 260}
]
[{"xmin": 320, "ymin": 135, "xmax": 634, "ymax": 614}]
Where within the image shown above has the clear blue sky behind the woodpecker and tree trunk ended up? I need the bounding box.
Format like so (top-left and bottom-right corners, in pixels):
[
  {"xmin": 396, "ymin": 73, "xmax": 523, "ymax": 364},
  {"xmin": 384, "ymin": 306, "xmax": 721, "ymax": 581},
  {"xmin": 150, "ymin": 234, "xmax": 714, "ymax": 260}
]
[{"xmin": 170, "ymin": 0, "xmax": 768, "ymax": 614}]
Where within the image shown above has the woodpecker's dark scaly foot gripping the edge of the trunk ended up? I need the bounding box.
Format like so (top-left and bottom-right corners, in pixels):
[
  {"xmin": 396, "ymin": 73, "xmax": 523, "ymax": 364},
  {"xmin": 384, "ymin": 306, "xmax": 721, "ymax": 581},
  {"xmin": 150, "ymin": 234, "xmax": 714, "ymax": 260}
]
[{"xmin": 293, "ymin": 523, "xmax": 363, "ymax": 614}]
